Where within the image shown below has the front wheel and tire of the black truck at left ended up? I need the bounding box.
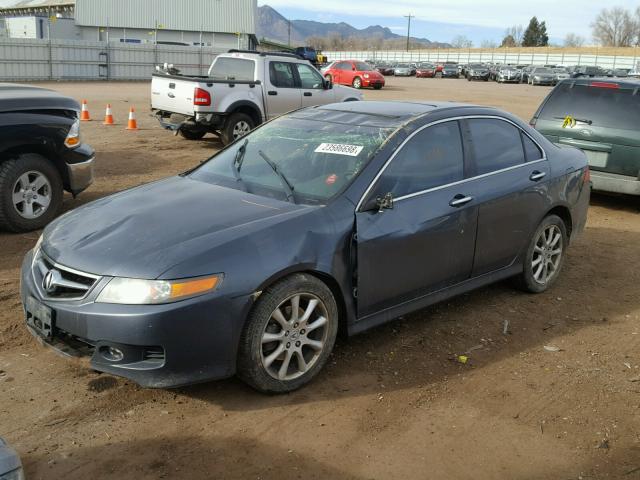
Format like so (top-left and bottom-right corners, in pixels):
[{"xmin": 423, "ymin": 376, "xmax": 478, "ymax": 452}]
[{"xmin": 0, "ymin": 153, "xmax": 63, "ymax": 232}]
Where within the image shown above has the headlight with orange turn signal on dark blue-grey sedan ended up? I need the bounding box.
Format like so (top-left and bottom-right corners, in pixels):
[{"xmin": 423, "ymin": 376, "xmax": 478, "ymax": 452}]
[{"xmin": 96, "ymin": 275, "xmax": 222, "ymax": 305}]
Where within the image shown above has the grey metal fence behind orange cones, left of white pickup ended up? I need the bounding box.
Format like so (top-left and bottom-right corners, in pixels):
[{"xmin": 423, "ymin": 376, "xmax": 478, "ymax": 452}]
[{"xmin": 0, "ymin": 38, "xmax": 221, "ymax": 81}]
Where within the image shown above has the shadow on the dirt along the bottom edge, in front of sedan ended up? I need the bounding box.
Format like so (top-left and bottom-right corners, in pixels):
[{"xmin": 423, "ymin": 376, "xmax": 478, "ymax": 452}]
[{"xmin": 22, "ymin": 434, "xmax": 360, "ymax": 480}]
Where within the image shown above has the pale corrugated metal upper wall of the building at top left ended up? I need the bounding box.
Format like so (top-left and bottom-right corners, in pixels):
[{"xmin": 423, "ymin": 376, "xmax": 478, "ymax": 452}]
[{"xmin": 75, "ymin": 0, "xmax": 257, "ymax": 34}]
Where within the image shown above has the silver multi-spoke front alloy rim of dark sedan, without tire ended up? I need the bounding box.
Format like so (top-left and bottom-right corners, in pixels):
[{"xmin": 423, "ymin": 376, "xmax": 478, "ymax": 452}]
[{"xmin": 261, "ymin": 293, "xmax": 330, "ymax": 381}]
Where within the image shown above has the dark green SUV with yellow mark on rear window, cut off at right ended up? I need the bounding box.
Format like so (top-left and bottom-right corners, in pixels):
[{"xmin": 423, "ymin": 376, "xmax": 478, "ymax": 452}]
[{"xmin": 531, "ymin": 78, "xmax": 640, "ymax": 195}]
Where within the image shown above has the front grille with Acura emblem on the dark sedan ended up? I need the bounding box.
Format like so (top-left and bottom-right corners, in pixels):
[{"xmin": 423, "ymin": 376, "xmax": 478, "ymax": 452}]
[{"xmin": 33, "ymin": 249, "xmax": 99, "ymax": 300}]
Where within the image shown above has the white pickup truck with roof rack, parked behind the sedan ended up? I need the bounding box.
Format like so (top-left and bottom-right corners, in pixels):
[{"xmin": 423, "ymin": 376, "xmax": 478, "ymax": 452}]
[{"xmin": 151, "ymin": 50, "xmax": 363, "ymax": 145}]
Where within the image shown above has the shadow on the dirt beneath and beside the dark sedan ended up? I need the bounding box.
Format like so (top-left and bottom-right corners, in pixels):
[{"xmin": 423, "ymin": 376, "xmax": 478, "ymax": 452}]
[{"xmin": 178, "ymin": 224, "xmax": 640, "ymax": 411}]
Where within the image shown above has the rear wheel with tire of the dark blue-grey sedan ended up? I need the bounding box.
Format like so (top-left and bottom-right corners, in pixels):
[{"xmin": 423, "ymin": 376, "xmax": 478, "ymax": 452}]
[{"xmin": 516, "ymin": 215, "xmax": 568, "ymax": 293}]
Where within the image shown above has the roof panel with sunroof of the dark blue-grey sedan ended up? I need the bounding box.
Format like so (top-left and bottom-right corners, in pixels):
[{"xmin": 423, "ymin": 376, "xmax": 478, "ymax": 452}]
[{"xmin": 291, "ymin": 101, "xmax": 483, "ymax": 128}]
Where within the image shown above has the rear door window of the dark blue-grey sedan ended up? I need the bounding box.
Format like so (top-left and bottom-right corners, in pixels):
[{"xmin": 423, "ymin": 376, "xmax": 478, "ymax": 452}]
[{"xmin": 467, "ymin": 118, "xmax": 525, "ymax": 175}]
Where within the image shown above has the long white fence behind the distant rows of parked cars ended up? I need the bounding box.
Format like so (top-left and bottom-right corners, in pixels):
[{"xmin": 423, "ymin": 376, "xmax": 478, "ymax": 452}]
[{"xmin": 324, "ymin": 48, "xmax": 640, "ymax": 69}]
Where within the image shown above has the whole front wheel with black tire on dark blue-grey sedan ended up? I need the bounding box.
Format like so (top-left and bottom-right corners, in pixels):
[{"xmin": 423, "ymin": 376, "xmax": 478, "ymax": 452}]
[{"xmin": 237, "ymin": 273, "xmax": 338, "ymax": 393}]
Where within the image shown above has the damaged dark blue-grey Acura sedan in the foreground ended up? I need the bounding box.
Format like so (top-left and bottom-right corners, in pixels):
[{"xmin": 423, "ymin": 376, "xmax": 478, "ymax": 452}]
[{"xmin": 21, "ymin": 102, "xmax": 589, "ymax": 392}]
